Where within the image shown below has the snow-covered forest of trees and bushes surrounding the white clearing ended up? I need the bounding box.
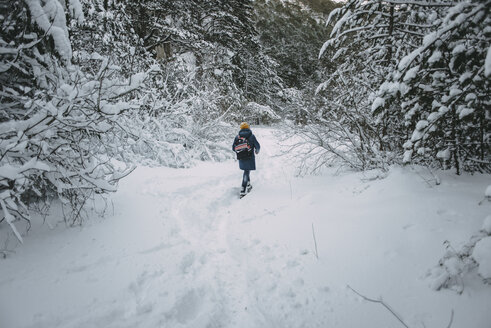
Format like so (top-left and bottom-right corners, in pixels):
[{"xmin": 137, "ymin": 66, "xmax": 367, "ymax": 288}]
[{"xmin": 0, "ymin": 0, "xmax": 491, "ymax": 241}]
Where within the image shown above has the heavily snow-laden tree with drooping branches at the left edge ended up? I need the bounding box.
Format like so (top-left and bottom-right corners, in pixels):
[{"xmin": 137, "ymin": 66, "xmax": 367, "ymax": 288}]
[{"xmin": 0, "ymin": 0, "xmax": 146, "ymax": 240}]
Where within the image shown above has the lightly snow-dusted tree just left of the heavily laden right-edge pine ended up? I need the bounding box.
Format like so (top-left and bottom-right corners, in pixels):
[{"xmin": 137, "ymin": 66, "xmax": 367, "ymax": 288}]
[{"xmin": 317, "ymin": 0, "xmax": 456, "ymax": 168}]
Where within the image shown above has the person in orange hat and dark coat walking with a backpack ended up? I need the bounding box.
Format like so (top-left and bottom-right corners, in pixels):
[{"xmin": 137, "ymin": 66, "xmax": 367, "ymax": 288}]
[{"xmin": 232, "ymin": 122, "xmax": 261, "ymax": 198}]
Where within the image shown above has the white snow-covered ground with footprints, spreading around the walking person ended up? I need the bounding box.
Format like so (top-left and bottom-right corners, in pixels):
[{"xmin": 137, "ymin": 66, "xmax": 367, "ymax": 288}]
[{"xmin": 0, "ymin": 127, "xmax": 491, "ymax": 328}]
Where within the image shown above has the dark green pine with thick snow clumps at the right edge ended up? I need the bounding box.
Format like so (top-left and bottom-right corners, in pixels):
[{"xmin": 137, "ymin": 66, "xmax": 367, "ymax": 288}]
[{"xmin": 374, "ymin": 1, "xmax": 491, "ymax": 174}]
